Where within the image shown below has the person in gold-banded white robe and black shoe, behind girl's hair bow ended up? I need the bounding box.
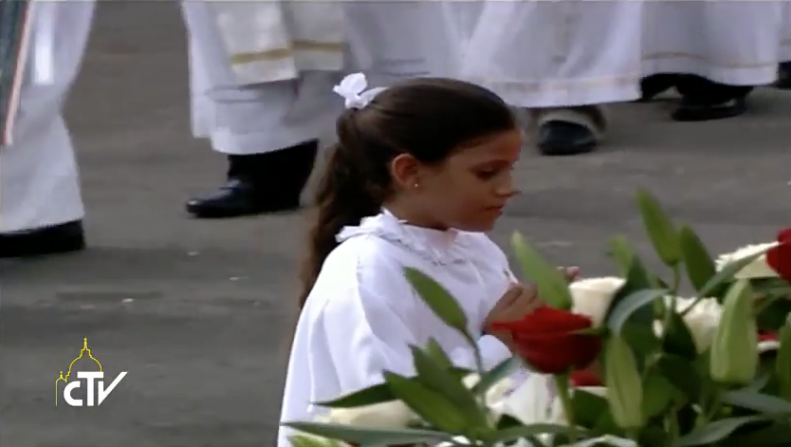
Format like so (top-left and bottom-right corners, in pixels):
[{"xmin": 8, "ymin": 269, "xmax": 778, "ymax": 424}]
[{"xmin": 183, "ymin": 1, "xmax": 427, "ymax": 217}]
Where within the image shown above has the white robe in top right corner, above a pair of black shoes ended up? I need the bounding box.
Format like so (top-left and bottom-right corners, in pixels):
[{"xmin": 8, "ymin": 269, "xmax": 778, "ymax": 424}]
[{"xmin": 643, "ymin": 1, "xmax": 791, "ymax": 86}]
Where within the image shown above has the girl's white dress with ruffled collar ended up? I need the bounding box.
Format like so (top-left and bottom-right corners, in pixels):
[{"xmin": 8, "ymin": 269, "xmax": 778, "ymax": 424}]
[{"xmin": 278, "ymin": 211, "xmax": 514, "ymax": 447}]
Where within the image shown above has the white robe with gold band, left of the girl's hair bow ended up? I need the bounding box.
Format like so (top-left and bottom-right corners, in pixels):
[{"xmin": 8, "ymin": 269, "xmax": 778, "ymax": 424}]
[{"xmin": 182, "ymin": 1, "xmax": 343, "ymax": 155}]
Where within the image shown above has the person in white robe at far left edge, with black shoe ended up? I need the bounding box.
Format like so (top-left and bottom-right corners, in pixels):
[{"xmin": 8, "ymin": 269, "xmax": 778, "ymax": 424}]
[{"xmin": 0, "ymin": 1, "xmax": 94, "ymax": 258}]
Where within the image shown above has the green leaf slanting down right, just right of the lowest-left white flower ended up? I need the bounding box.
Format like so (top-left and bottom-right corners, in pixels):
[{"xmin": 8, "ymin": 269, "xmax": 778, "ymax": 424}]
[{"xmin": 384, "ymin": 371, "xmax": 467, "ymax": 434}]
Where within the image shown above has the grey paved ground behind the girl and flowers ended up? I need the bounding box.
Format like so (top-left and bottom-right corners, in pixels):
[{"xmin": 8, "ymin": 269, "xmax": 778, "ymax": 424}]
[{"xmin": 0, "ymin": 3, "xmax": 791, "ymax": 447}]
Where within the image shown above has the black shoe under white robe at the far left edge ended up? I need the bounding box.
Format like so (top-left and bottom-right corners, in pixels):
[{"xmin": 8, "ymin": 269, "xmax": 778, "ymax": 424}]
[{"xmin": 0, "ymin": 221, "xmax": 85, "ymax": 259}]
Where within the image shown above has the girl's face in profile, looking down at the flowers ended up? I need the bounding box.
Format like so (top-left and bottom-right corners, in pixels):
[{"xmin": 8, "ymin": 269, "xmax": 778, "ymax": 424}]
[{"xmin": 413, "ymin": 129, "xmax": 523, "ymax": 231}]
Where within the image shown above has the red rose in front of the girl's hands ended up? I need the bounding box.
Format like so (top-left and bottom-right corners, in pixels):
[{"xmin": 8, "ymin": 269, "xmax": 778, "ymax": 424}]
[{"xmin": 492, "ymin": 307, "xmax": 601, "ymax": 374}]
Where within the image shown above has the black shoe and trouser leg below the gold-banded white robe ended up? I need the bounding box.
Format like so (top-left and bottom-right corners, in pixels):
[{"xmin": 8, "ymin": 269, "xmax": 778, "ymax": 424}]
[{"xmin": 187, "ymin": 141, "xmax": 318, "ymax": 219}]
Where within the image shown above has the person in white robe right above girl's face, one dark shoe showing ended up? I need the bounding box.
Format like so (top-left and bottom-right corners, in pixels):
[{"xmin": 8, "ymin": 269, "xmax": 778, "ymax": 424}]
[{"xmin": 450, "ymin": 1, "xmax": 643, "ymax": 155}]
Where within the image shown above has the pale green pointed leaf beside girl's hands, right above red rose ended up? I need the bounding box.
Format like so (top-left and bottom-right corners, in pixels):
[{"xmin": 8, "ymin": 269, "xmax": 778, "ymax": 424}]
[{"xmin": 511, "ymin": 232, "xmax": 573, "ymax": 310}]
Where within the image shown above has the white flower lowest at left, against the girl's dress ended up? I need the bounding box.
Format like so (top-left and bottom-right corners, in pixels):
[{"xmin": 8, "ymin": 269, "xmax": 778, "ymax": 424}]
[{"xmin": 317, "ymin": 401, "xmax": 416, "ymax": 428}]
